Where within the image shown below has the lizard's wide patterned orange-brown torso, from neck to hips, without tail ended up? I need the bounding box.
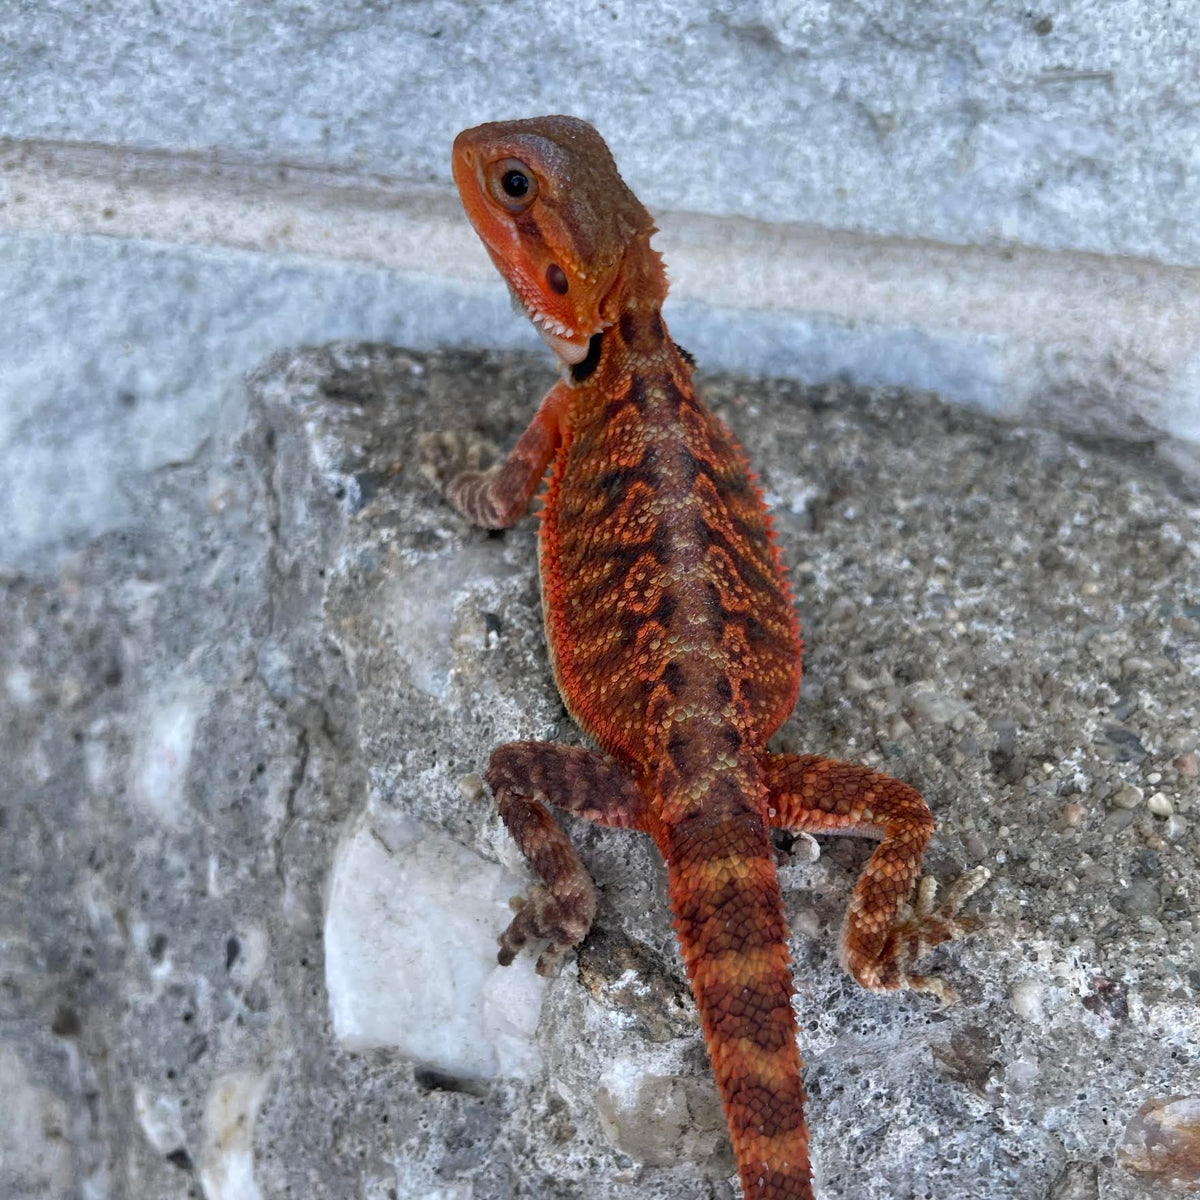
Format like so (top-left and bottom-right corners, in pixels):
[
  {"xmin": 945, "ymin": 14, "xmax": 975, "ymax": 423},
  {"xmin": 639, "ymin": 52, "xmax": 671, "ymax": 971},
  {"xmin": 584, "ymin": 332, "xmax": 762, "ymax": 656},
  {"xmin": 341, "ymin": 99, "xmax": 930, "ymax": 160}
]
[{"xmin": 541, "ymin": 319, "xmax": 799, "ymax": 775}]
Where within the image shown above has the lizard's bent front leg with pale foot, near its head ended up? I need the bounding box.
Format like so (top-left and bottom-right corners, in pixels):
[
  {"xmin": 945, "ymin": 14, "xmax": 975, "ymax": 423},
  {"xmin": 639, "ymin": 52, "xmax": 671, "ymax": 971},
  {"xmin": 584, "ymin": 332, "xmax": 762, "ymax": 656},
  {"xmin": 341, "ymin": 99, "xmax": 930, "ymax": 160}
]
[{"xmin": 416, "ymin": 380, "xmax": 571, "ymax": 529}]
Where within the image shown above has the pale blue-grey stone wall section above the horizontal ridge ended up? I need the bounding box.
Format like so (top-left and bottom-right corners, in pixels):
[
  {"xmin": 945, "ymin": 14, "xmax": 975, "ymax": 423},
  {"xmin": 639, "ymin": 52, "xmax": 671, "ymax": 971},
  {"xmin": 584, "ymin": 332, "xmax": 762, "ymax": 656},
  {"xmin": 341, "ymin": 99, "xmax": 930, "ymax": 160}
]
[{"xmin": 0, "ymin": 0, "xmax": 1200, "ymax": 266}]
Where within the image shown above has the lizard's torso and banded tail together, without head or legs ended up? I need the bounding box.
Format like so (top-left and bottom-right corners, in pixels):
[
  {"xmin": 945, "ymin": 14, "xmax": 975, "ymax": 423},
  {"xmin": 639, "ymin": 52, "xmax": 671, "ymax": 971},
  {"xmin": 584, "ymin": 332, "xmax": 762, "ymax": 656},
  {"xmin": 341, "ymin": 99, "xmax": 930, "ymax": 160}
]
[{"xmin": 541, "ymin": 302, "xmax": 811, "ymax": 1198}]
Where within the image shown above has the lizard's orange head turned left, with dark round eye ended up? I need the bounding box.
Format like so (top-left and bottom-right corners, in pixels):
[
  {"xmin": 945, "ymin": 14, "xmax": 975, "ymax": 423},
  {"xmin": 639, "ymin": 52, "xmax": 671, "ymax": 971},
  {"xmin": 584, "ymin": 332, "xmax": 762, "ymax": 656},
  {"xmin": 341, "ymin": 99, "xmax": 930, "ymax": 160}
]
[{"xmin": 452, "ymin": 116, "xmax": 665, "ymax": 364}]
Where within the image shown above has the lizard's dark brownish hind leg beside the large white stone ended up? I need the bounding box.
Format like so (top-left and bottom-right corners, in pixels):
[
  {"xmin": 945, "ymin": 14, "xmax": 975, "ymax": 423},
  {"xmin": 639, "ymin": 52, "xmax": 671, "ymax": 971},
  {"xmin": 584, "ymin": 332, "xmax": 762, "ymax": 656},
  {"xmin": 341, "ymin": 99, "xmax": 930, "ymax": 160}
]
[{"xmin": 487, "ymin": 742, "xmax": 644, "ymax": 974}]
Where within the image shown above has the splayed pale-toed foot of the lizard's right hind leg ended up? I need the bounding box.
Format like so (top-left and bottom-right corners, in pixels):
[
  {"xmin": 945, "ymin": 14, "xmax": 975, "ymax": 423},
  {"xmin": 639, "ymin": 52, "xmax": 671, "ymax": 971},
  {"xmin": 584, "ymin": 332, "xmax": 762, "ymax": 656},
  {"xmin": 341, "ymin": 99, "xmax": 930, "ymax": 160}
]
[{"xmin": 842, "ymin": 866, "xmax": 991, "ymax": 1006}]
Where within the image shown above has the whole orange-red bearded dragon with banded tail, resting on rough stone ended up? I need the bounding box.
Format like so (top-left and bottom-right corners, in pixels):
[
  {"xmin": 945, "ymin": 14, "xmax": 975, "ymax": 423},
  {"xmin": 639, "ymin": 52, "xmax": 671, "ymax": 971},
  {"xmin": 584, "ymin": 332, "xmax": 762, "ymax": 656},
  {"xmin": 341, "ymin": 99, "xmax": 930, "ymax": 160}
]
[{"xmin": 421, "ymin": 116, "xmax": 988, "ymax": 1200}]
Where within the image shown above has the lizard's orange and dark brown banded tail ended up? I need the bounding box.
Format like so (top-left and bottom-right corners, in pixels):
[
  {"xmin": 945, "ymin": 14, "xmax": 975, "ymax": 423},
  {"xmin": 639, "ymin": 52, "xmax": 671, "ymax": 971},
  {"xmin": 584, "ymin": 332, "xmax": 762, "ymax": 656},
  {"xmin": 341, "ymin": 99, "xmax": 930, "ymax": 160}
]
[{"xmin": 664, "ymin": 768, "xmax": 812, "ymax": 1200}]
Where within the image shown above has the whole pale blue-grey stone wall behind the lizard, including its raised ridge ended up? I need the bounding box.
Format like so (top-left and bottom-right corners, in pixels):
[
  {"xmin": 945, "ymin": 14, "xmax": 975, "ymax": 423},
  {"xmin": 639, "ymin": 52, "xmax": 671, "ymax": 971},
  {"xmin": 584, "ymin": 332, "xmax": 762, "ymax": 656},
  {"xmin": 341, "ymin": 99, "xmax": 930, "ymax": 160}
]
[{"xmin": 0, "ymin": 0, "xmax": 1200, "ymax": 557}]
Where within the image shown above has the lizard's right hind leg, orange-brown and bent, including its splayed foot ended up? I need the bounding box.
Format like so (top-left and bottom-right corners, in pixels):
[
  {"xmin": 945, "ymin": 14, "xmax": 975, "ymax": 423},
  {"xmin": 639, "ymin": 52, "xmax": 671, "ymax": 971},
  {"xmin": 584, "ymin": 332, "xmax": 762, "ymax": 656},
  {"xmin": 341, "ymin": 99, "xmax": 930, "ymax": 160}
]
[{"xmin": 763, "ymin": 755, "xmax": 990, "ymax": 1003}]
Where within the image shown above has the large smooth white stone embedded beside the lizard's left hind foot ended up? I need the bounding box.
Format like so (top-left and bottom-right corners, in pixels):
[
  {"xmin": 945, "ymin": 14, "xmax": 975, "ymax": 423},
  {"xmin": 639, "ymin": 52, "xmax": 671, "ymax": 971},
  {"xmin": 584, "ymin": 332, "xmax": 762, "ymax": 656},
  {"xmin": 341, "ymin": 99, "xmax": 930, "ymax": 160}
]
[{"xmin": 325, "ymin": 811, "xmax": 546, "ymax": 1079}]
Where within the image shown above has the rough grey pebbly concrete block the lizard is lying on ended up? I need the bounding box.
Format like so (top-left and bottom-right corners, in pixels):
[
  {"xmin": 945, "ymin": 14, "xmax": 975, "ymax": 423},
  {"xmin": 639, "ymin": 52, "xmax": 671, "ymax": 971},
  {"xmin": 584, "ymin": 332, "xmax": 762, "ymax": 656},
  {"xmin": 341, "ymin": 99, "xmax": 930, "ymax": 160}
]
[{"xmin": 0, "ymin": 346, "xmax": 1200, "ymax": 1200}]
